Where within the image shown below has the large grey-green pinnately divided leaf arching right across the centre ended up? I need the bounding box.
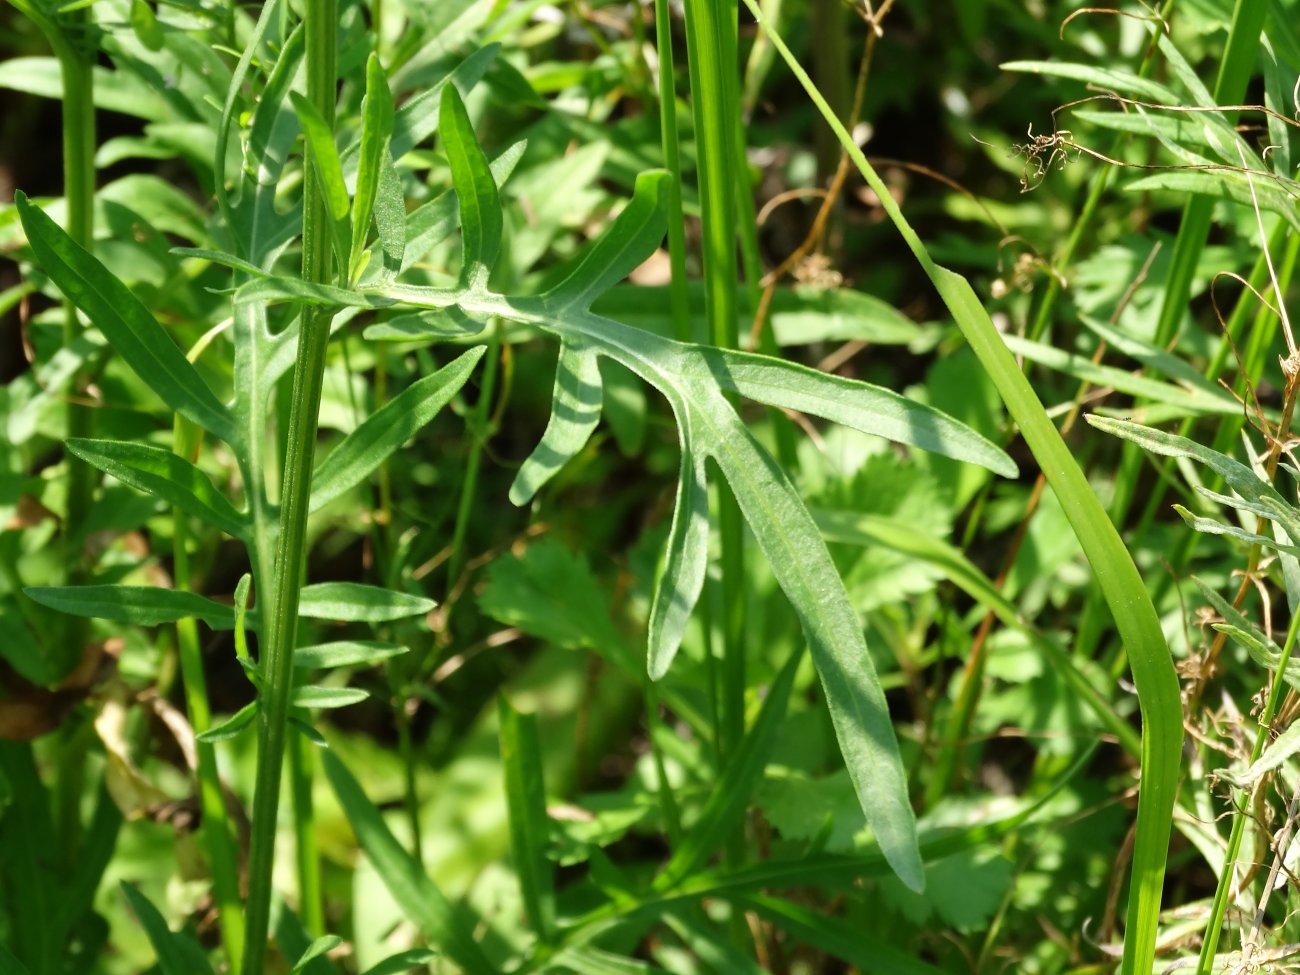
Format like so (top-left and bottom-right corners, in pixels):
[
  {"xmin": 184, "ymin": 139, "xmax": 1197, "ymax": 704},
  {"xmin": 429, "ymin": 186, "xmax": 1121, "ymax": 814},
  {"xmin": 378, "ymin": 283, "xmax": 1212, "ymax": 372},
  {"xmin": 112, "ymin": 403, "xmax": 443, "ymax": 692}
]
[{"xmin": 231, "ymin": 86, "xmax": 1017, "ymax": 889}]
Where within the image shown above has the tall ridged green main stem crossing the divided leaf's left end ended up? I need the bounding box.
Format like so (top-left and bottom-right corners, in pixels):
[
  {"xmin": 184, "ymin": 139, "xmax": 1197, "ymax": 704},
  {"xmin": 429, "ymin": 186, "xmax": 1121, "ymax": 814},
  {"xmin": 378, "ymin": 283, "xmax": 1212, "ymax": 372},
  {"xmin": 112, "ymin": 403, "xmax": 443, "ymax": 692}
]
[{"xmin": 244, "ymin": 0, "xmax": 338, "ymax": 975}]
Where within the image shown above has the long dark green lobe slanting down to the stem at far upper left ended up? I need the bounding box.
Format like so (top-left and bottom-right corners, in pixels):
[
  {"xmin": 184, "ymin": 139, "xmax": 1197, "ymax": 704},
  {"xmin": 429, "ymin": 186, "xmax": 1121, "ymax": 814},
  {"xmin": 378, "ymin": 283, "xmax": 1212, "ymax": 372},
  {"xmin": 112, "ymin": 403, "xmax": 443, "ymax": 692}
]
[{"xmin": 14, "ymin": 191, "xmax": 238, "ymax": 443}]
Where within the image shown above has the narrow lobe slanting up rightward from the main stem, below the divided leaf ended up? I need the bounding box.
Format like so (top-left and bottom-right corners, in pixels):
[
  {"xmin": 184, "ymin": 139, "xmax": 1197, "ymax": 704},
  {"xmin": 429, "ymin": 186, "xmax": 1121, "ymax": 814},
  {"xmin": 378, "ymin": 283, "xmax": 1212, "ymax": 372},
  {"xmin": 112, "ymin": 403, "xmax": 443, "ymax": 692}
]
[{"xmin": 311, "ymin": 346, "xmax": 486, "ymax": 511}]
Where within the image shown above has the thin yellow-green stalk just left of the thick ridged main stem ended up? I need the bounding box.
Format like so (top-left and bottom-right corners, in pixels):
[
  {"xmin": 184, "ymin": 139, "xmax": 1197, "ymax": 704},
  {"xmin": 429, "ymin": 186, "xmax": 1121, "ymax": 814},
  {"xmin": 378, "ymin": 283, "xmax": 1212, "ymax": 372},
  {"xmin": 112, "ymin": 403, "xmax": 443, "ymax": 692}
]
[{"xmin": 172, "ymin": 415, "xmax": 244, "ymax": 975}]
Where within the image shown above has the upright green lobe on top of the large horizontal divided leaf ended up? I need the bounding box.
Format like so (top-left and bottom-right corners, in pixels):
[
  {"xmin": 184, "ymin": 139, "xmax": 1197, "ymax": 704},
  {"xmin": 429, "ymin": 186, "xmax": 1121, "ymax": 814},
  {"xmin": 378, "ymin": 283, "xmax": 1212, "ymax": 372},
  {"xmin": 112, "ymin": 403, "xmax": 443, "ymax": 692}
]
[{"xmin": 438, "ymin": 85, "xmax": 502, "ymax": 291}]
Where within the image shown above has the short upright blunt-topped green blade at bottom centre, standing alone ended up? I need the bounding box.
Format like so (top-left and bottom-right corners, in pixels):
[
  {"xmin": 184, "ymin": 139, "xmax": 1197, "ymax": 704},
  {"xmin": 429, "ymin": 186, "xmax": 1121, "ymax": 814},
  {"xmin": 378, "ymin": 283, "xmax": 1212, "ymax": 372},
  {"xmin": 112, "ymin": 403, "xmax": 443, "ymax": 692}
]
[{"xmin": 497, "ymin": 696, "xmax": 555, "ymax": 944}]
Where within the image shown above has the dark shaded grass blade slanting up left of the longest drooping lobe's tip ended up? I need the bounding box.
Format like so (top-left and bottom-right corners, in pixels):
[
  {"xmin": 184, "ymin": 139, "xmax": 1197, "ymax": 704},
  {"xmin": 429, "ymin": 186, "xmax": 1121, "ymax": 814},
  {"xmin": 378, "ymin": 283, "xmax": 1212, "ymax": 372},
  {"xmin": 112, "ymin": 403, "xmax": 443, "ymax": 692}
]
[{"xmin": 654, "ymin": 650, "xmax": 800, "ymax": 892}]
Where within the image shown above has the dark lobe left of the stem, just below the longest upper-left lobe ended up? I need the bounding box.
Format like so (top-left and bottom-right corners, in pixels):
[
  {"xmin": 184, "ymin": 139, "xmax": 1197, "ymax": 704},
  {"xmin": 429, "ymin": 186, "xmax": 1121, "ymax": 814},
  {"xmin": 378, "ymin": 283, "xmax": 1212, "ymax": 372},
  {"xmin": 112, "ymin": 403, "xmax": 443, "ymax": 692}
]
[{"xmin": 68, "ymin": 438, "xmax": 248, "ymax": 538}]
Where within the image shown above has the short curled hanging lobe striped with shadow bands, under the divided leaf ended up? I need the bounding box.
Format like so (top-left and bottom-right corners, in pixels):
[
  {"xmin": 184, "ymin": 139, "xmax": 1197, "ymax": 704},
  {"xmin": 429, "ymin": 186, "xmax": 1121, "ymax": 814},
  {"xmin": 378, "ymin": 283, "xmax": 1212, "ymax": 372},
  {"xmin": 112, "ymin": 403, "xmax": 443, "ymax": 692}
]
[{"xmin": 510, "ymin": 342, "xmax": 601, "ymax": 504}]
